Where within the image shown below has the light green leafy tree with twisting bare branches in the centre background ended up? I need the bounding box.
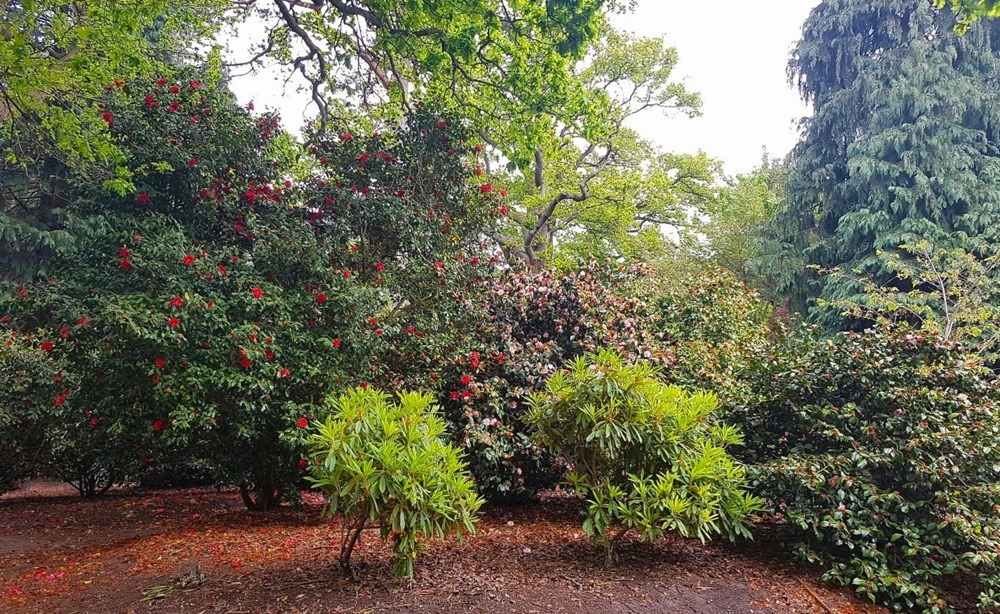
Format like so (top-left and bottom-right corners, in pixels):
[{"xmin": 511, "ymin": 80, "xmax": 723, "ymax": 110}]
[{"xmin": 487, "ymin": 28, "xmax": 718, "ymax": 267}]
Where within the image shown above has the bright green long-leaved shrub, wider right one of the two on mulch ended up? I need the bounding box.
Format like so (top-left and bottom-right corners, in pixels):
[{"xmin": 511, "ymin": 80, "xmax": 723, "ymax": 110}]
[{"xmin": 525, "ymin": 350, "xmax": 759, "ymax": 563}]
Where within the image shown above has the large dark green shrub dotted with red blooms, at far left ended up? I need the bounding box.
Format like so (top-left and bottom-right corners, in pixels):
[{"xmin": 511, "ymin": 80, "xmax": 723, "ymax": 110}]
[{"xmin": 0, "ymin": 73, "xmax": 372, "ymax": 509}]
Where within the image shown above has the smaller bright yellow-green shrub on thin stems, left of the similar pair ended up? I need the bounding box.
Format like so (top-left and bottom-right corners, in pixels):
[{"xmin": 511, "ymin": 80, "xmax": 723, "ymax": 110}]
[{"xmin": 310, "ymin": 388, "xmax": 483, "ymax": 577}]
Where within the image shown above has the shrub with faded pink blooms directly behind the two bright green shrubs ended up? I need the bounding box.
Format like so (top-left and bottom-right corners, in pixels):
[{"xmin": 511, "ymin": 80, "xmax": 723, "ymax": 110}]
[{"xmin": 434, "ymin": 264, "xmax": 660, "ymax": 500}]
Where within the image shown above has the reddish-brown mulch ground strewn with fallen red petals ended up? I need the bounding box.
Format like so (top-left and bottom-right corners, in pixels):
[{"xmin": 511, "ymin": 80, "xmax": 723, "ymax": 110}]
[{"xmin": 0, "ymin": 483, "xmax": 900, "ymax": 614}]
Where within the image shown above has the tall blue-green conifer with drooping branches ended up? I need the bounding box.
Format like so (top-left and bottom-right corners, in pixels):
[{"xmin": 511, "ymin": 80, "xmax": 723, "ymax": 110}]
[{"xmin": 762, "ymin": 0, "xmax": 1000, "ymax": 325}]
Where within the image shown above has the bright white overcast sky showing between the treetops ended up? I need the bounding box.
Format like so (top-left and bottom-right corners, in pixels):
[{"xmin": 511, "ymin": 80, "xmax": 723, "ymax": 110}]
[{"xmin": 227, "ymin": 0, "xmax": 819, "ymax": 175}]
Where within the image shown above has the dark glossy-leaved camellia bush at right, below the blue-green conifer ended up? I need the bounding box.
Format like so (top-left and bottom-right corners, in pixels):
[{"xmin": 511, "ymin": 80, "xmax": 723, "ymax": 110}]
[{"xmin": 727, "ymin": 328, "xmax": 1000, "ymax": 612}]
